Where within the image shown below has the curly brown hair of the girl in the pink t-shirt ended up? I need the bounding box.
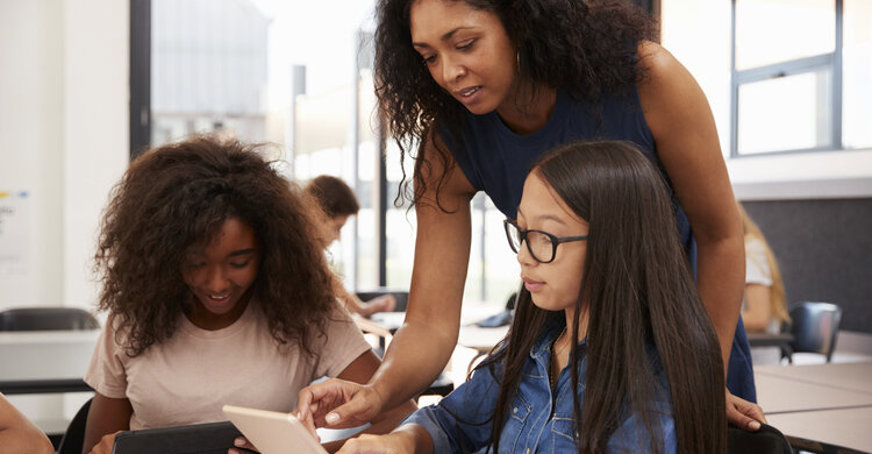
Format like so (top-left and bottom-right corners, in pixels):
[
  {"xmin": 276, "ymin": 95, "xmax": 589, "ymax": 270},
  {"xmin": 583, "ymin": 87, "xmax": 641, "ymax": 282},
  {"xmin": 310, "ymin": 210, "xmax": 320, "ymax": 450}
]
[{"xmin": 95, "ymin": 136, "xmax": 334, "ymax": 356}]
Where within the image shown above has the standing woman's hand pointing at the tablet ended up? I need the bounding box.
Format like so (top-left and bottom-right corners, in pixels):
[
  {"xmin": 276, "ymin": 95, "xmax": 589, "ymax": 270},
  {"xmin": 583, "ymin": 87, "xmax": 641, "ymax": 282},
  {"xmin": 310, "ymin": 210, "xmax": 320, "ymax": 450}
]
[{"xmin": 297, "ymin": 378, "xmax": 385, "ymax": 437}]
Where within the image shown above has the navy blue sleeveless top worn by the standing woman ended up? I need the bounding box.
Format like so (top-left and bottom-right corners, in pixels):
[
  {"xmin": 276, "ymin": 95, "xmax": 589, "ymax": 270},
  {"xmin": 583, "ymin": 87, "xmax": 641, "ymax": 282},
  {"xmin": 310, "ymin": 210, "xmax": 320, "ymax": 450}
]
[{"xmin": 441, "ymin": 88, "xmax": 756, "ymax": 402}]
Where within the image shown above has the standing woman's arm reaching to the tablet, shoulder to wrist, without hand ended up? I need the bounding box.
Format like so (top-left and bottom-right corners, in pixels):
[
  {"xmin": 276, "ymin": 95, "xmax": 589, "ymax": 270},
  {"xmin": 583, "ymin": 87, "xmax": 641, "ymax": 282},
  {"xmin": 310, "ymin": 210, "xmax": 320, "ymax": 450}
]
[{"xmin": 370, "ymin": 139, "xmax": 475, "ymax": 407}]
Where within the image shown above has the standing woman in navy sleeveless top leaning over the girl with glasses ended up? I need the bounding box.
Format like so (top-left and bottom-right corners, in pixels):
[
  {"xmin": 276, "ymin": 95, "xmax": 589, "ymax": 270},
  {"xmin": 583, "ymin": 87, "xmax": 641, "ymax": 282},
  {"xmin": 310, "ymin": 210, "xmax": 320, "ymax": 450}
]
[{"xmin": 300, "ymin": 0, "xmax": 763, "ymax": 430}]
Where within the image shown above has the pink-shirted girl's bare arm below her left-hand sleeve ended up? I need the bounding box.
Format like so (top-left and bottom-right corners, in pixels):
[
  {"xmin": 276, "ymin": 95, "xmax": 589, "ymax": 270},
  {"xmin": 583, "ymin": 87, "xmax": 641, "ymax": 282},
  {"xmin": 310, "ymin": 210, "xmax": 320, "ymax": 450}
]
[{"xmin": 82, "ymin": 393, "xmax": 133, "ymax": 453}]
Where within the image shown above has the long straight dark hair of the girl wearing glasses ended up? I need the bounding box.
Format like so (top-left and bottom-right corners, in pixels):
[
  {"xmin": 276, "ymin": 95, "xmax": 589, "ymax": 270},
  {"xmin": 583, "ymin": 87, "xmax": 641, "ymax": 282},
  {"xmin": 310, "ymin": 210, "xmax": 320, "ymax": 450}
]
[{"xmin": 479, "ymin": 141, "xmax": 727, "ymax": 453}]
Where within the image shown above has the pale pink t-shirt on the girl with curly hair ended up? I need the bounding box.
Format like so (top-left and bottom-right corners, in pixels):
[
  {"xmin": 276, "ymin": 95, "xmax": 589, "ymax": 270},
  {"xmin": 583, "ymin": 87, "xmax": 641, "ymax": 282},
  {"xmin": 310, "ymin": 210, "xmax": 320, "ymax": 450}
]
[{"xmin": 85, "ymin": 301, "xmax": 371, "ymax": 430}]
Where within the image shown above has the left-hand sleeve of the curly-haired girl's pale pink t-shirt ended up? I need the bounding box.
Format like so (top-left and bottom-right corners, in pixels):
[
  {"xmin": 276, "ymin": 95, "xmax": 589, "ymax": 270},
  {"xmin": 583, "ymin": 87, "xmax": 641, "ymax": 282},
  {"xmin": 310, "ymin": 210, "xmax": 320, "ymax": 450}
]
[{"xmin": 84, "ymin": 317, "xmax": 127, "ymax": 399}]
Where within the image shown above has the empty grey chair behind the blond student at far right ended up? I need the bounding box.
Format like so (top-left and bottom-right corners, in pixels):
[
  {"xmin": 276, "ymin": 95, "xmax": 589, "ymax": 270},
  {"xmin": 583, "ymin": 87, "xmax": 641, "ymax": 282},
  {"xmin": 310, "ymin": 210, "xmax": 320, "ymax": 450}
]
[{"xmin": 782, "ymin": 301, "xmax": 842, "ymax": 364}]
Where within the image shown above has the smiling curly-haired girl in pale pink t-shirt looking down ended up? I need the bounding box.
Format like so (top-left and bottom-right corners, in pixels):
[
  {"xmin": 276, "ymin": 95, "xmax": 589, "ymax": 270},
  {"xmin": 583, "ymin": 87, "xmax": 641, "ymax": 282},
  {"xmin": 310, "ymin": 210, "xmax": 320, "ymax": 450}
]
[{"xmin": 84, "ymin": 137, "xmax": 414, "ymax": 453}]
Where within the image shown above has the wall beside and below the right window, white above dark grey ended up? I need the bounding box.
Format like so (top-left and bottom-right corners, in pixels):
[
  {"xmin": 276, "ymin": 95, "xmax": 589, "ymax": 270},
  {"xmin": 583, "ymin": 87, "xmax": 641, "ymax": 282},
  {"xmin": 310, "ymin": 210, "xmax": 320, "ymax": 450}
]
[{"xmin": 661, "ymin": 0, "xmax": 872, "ymax": 333}]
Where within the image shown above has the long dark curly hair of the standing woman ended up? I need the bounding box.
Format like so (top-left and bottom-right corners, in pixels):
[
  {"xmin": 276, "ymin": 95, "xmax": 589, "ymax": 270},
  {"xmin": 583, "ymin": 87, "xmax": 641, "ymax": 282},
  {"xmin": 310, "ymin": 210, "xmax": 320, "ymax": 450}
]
[{"xmin": 375, "ymin": 0, "xmax": 657, "ymax": 209}]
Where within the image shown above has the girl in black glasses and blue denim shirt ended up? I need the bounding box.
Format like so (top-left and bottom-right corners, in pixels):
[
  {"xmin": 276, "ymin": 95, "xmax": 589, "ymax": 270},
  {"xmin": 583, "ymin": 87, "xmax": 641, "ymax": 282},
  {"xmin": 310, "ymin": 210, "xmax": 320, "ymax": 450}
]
[{"xmin": 340, "ymin": 142, "xmax": 727, "ymax": 453}]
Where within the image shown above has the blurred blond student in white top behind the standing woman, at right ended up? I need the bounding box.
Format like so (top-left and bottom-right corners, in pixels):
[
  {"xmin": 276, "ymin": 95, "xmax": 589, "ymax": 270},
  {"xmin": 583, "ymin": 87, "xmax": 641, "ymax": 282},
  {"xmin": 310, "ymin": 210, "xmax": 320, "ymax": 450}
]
[{"xmin": 738, "ymin": 203, "xmax": 790, "ymax": 365}]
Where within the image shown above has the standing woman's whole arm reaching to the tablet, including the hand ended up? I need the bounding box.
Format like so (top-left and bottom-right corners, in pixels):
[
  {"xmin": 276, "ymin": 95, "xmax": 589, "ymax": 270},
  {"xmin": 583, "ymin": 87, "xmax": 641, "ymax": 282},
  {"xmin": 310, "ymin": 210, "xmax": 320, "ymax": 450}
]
[{"xmin": 298, "ymin": 135, "xmax": 475, "ymax": 427}]
